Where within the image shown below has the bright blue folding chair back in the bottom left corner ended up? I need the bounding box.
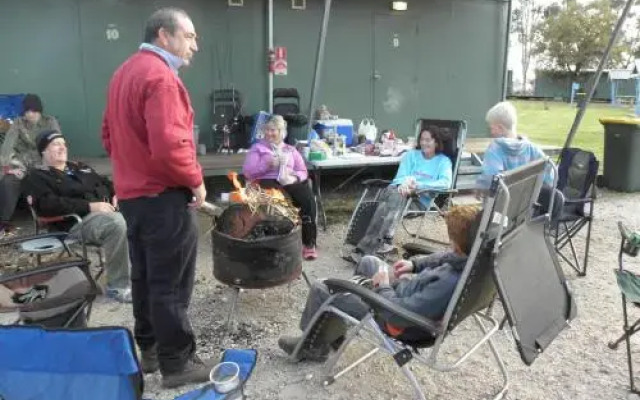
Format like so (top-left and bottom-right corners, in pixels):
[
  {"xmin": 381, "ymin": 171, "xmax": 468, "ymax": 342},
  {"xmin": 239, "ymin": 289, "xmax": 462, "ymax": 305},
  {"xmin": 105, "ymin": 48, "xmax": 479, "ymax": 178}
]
[{"xmin": 0, "ymin": 325, "xmax": 144, "ymax": 400}]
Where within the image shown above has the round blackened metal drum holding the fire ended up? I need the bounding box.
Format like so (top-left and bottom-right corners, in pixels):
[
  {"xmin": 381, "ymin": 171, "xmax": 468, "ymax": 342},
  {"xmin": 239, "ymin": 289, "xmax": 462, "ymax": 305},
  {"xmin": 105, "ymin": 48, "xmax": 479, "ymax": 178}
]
[{"xmin": 211, "ymin": 226, "xmax": 302, "ymax": 289}]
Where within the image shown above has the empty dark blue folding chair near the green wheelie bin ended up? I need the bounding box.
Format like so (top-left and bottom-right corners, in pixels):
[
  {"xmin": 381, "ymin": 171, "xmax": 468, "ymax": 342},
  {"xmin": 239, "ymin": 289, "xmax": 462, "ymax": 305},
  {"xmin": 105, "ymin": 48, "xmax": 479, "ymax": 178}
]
[{"xmin": 550, "ymin": 148, "xmax": 598, "ymax": 276}]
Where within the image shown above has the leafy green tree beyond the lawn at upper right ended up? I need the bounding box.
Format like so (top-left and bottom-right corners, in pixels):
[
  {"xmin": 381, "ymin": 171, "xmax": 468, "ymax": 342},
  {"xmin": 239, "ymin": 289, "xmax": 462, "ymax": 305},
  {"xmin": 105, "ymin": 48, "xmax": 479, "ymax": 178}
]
[{"xmin": 534, "ymin": 0, "xmax": 629, "ymax": 78}]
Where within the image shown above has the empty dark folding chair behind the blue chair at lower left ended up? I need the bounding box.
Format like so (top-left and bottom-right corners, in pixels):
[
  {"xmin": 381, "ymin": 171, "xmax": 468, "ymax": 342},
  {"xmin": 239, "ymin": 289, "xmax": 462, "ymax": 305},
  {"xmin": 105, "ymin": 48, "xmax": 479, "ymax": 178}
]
[{"xmin": 0, "ymin": 233, "xmax": 100, "ymax": 327}]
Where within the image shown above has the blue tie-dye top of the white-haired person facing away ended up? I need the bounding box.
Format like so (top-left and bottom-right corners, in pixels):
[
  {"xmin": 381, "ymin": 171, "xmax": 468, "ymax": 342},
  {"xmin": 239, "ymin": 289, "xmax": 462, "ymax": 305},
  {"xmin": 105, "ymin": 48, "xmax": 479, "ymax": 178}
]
[{"xmin": 478, "ymin": 136, "xmax": 553, "ymax": 188}]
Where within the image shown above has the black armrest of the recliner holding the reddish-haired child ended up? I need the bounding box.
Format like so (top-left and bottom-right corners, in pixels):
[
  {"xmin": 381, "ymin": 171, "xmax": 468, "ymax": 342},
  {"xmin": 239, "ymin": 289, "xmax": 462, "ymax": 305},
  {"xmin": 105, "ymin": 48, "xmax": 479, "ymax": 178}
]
[{"xmin": 324, "ymin": 279, "xmax": 442, "ymax": 336}]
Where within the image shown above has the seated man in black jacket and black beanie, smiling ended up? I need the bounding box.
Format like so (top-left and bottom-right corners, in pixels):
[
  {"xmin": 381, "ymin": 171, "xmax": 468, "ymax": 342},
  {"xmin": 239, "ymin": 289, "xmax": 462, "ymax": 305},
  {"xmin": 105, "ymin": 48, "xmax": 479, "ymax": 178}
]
[{"xmin": 25, "ymin": 130, "xmax": 131, "ymax": 303}]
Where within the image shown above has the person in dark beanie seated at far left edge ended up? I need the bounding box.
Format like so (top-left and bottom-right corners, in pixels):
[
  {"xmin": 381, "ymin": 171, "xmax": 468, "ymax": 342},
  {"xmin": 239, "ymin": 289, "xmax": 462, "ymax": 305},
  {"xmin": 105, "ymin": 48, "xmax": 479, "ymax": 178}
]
[{"xmin": 0, "ymin": 94, "xmax": 60, "ymax": 238}]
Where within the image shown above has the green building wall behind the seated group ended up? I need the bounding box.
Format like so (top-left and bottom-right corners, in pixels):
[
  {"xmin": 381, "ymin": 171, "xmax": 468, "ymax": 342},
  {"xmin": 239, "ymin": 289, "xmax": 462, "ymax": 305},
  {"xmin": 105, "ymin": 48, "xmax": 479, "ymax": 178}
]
[{"xmin": 0, "ymin": 0, "xmax": 507, "ymax": 156}]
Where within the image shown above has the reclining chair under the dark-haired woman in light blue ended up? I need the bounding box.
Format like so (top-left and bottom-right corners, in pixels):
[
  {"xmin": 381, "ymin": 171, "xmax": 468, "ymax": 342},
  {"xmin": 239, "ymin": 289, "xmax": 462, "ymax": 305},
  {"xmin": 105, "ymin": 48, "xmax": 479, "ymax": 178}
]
[{"xmin": 344, "ymin": 119, "xmax": 467, "ymax": 253}]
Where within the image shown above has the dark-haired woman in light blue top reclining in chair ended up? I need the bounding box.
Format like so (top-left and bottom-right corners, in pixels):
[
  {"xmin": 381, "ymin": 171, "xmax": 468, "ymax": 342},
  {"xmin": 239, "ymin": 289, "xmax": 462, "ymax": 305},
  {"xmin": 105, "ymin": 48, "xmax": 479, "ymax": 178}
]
[{"xmin": 355, "ymin": 126, "xmax": 453, "ymax": 258}]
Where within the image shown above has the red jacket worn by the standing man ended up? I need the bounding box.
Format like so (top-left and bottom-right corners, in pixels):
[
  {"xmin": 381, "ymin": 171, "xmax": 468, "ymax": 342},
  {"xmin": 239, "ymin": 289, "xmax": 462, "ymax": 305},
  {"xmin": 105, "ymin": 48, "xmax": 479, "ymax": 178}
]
[{"xmin": 102, "ymin": 50, "xmax": 202, "ymax": 199}]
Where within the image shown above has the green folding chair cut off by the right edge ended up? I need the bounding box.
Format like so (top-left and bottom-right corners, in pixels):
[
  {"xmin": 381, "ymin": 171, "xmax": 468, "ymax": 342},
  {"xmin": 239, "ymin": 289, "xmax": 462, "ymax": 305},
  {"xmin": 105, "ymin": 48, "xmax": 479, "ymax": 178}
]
[{"xmin": 609, "ymin": 222, "xmax": 640, "ymax": 394}]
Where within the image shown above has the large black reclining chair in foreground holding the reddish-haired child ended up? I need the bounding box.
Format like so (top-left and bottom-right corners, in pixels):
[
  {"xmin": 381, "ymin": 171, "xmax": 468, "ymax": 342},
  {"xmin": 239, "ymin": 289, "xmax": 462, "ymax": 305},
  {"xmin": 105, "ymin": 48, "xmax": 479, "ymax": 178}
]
[{"xmin": 291, "ymin": 160, "xmax": 575, "ymax": 399}]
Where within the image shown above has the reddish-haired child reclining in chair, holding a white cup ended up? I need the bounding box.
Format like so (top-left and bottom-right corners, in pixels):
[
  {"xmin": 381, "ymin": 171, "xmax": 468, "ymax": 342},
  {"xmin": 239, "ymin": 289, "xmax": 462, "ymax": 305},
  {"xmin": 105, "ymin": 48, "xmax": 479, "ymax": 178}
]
[{"xmin": 278, "ymin": 206, "xmax": 479, "ymax": 361}]
